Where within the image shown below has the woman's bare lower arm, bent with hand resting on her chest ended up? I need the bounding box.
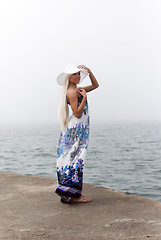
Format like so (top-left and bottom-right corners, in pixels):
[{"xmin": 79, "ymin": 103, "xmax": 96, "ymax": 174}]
[{"xmin": 67, "ymin": 89, "xmax": 87, "ymax": 118}]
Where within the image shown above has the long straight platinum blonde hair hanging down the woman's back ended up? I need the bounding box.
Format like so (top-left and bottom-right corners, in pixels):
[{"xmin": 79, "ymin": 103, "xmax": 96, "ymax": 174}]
[{"xmin": 58, "ymin": 74, "xmax": 70, "ymax": 132}]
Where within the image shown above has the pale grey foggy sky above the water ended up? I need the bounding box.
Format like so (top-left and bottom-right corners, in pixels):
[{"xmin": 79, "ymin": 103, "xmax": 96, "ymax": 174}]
[{"xmin": 0, "ymin": 0, "xmax": 161, "ymax": 124}]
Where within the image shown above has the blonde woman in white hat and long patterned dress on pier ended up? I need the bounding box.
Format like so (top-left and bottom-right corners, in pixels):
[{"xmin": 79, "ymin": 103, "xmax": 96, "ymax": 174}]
[{"xmin": 56, "ymin": 64, "xmax": 99, "ymax": 203}]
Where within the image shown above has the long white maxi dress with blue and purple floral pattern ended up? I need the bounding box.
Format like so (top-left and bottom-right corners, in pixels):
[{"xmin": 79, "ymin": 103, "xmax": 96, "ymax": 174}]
[{"xmin": 55, "ymin": 96, "xmax": 89, "ymax": 203}]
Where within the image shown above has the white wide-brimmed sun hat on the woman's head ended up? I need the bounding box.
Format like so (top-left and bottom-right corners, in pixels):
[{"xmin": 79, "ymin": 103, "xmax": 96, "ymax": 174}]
[{"xmin": 57, "ymin": 64, "xmax": 88, "ymax": 85}]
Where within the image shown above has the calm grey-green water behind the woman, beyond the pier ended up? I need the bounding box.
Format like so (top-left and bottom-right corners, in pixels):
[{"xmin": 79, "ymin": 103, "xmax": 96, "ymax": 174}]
[{"xmin": 0, "ymin": 123, "xmax": 161, "ymax": 202}]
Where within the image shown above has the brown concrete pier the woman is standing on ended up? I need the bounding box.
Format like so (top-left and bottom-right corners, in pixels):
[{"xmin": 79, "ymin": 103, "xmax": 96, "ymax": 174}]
[{"xmin": 0, "ymin": 173, "xmax": 161, "ymax": 240}]
